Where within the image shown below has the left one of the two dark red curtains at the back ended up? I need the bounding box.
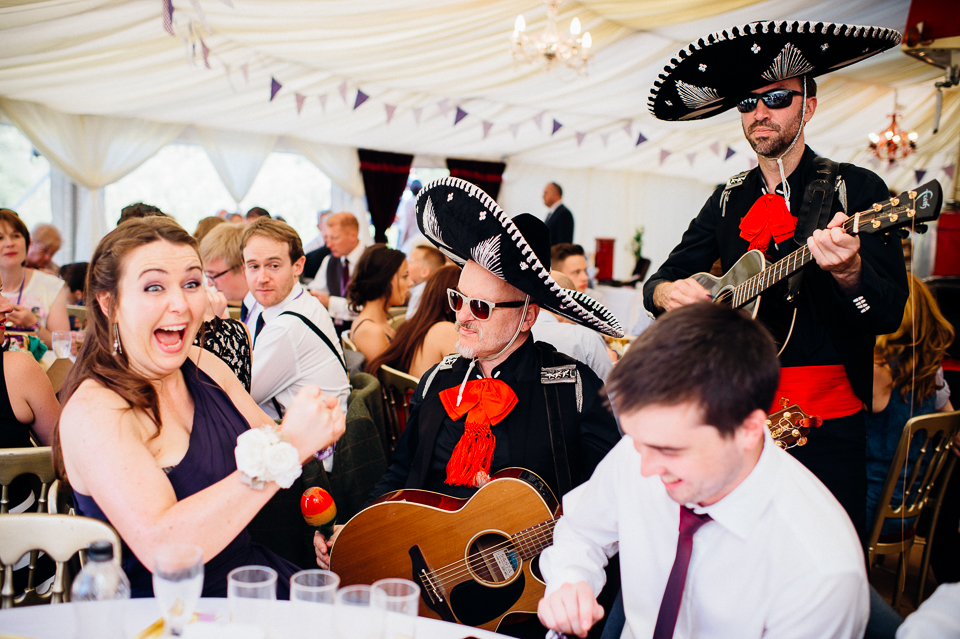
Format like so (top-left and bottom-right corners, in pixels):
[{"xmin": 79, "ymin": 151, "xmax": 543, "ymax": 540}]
[{"xmin": 358, "ymin": 149, "xmax": 413, "ymax": 243}]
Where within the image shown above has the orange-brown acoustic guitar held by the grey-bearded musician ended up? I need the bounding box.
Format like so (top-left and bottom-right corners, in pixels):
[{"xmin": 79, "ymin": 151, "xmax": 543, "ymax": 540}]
[{"xmin": 330, "ymin": 468, "xmax": 560, "ymax": 630}]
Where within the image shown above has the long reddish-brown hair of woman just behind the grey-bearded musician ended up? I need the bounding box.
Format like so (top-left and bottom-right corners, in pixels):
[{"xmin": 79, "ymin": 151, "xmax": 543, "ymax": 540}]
[{"xmin": 366, "ymin": 266, "xmax": 460, "ymax": 375}]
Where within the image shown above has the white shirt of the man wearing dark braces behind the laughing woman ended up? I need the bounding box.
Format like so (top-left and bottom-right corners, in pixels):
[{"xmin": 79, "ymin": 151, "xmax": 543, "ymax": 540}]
[{"xmin": 250, "ymin": 284, "xmax": 350, "ymax": 419}]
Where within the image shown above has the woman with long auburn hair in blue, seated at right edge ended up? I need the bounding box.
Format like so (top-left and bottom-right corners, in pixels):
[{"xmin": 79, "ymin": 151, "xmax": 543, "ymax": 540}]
[{"xmin": 866, "ymin": 275, "xmax": 954, "ymax": 535}]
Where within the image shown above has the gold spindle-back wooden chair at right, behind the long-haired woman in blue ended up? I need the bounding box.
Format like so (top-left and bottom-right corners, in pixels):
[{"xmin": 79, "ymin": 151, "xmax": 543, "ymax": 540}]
[{"xmin": 867, "ymin": 411, "xmax": 960, "ymax": 607}]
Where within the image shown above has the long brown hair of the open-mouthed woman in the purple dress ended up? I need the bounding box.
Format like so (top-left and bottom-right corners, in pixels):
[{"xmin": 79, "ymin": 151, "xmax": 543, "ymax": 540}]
[{"xmin": 54, "ymin": 216, "xmax": 200, "ymax": 478}]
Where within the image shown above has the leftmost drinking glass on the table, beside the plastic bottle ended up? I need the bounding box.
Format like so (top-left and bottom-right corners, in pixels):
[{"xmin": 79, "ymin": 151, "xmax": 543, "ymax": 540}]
[{"xmin": 153, "ymin": 544, "xmax": 203, "ymax": 637}]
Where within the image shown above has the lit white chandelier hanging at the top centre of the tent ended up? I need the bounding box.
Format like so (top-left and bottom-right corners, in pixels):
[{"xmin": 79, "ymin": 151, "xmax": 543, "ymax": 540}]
[{"xmin": 513, "ymin": 0, "xmax": 593, "ymax": 74}]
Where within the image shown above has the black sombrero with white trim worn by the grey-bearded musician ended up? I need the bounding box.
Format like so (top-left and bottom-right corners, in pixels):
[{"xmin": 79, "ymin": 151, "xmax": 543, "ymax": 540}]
[{"xmin": 417, "ymin": 178, "xmax": 623, "ymax": 337}]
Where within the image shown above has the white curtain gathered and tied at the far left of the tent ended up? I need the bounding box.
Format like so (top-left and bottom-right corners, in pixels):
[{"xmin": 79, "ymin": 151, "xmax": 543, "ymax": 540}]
[{"xmin": 0, "ymin": 97, "xmax": 184, "ymax": 260}]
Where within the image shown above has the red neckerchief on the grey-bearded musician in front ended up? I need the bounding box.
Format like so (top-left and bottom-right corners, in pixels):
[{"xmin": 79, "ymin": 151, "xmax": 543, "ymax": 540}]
[{"xmin": 440, "ymin": 379, "xmax": 517, "ymax": 486}]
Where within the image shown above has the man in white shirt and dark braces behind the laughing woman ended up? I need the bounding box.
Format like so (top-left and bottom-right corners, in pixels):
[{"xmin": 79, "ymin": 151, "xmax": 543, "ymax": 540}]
[{"xmin": 241, "ymin": 217, "xmax": 350, "ymax": 432}]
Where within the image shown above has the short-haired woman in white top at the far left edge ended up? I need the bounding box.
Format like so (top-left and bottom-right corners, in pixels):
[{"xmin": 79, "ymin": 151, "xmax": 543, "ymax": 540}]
[{"xmin": 0, "ymin": 209, "xmax": 70, "ymax": 348}]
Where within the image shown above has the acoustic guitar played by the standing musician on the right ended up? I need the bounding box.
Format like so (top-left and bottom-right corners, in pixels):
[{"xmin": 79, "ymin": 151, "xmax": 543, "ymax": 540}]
[{"xmin": 692, "ymin": 180, "xmax": 943, "ymax": 353}]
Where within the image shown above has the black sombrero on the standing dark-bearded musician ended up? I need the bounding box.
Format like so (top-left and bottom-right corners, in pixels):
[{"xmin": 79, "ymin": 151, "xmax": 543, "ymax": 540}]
[{"xmin": 648, "ymin": 21, "xmax": 900, "ymax": 120}]
